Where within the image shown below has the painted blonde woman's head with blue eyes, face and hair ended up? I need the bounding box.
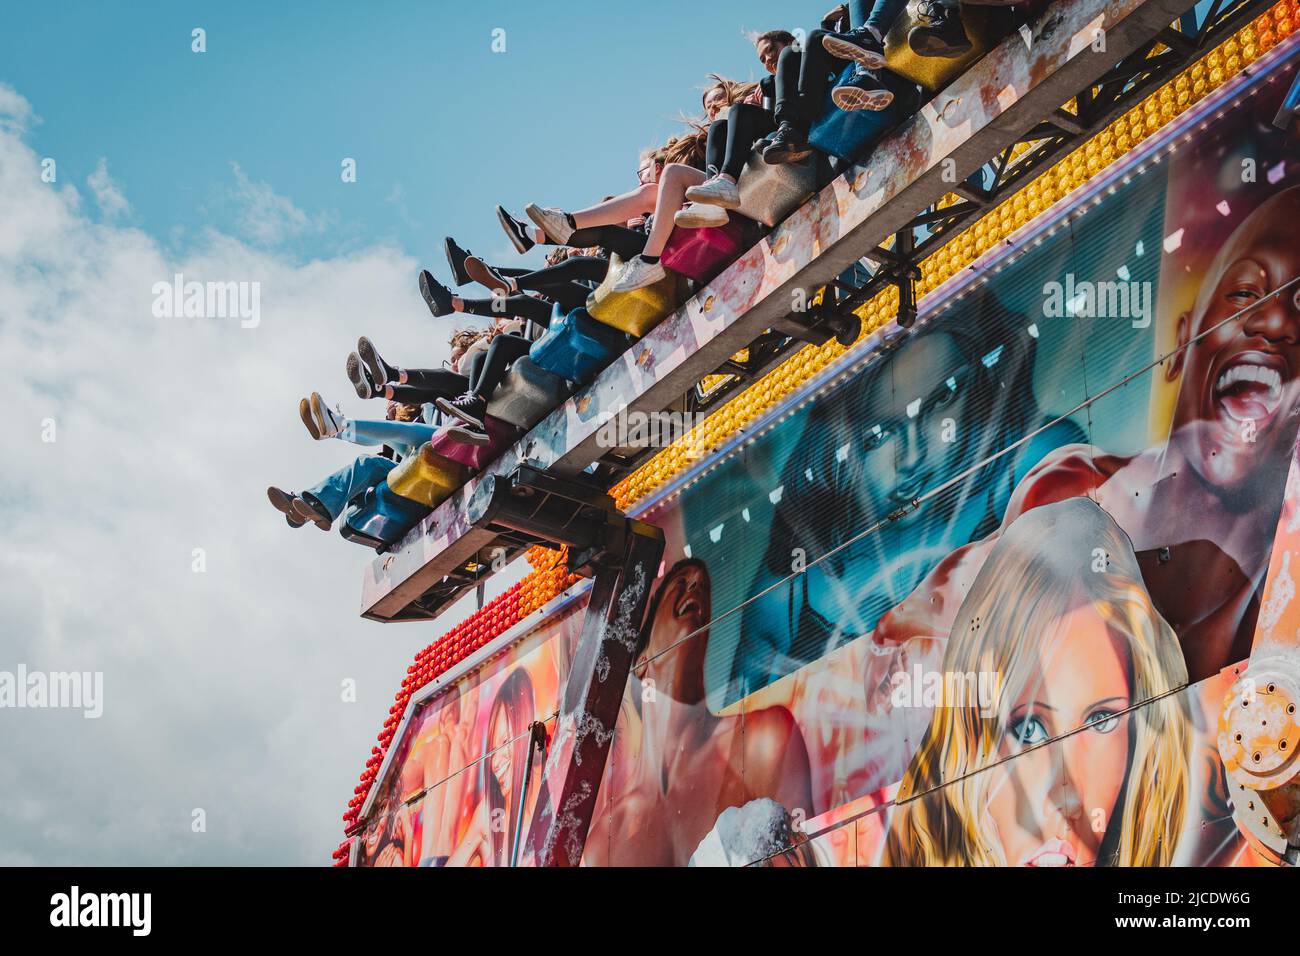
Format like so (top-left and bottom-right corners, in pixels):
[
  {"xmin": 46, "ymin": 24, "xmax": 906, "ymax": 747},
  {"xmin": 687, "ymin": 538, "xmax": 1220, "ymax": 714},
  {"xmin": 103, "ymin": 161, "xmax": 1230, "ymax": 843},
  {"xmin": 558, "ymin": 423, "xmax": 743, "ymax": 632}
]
[{"xmin": 883, "ymin": 496, "xmax": 1190, "ymax": 866}]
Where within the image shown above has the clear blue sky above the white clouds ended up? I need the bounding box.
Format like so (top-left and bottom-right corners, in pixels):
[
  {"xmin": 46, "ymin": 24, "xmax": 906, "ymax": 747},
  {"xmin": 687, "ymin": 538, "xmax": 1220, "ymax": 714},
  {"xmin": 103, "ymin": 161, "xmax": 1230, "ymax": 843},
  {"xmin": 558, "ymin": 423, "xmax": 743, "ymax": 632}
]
[{"xmin": 0, "ymin": 0, "xmax": 800, "ymax": 273}]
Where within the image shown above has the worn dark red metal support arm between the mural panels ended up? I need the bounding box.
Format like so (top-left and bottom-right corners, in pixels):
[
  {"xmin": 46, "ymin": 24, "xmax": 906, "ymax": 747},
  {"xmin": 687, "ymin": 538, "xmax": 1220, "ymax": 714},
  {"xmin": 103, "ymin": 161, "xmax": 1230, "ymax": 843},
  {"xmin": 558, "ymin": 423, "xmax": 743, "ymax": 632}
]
[{"xmin": 524, "ymin": 519, "xmax": 663, "ymax": 866}]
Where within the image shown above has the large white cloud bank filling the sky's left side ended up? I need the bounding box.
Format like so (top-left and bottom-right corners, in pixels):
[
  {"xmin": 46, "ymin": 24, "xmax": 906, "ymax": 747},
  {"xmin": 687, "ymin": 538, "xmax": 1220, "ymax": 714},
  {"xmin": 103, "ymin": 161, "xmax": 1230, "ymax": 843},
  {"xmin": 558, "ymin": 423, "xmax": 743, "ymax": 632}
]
[{"xmin": 0, "ymin": 87, "xmax": 460, "ymax": 865}]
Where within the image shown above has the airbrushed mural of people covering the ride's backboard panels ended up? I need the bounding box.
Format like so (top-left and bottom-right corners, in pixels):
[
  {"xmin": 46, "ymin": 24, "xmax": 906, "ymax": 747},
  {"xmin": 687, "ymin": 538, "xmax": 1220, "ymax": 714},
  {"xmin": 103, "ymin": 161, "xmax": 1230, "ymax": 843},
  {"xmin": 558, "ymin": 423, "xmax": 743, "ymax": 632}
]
[{"xmin": 363, "ymin": 59, "xmax": 1300, "ymax": 866}]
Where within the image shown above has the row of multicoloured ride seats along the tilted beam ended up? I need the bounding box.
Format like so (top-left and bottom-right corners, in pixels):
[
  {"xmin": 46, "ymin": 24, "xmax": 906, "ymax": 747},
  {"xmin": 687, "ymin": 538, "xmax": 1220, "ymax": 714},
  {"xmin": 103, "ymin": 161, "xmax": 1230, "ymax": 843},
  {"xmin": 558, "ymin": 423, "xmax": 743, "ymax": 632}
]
[{"xmin": 341, "ymin": 0, "xmax": 1044, "ymax": 551}]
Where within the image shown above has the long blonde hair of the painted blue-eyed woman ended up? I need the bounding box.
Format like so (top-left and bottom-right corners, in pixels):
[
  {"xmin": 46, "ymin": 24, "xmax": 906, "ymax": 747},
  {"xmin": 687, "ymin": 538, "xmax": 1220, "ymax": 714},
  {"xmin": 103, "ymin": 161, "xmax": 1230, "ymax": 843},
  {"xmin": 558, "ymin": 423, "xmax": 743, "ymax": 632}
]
[{"xmin": 881, "ymin": 498, "xmax": 1191, "ymax": 866}]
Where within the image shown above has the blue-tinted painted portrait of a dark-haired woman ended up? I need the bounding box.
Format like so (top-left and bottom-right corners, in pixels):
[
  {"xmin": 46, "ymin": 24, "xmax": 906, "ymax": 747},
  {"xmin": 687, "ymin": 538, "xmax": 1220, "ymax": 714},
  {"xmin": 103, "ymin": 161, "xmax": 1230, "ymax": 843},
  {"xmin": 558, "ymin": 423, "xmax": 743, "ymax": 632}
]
[{"xmin": 728, "ymin": 291, "xmax": 1083, "ymax": 698}]
